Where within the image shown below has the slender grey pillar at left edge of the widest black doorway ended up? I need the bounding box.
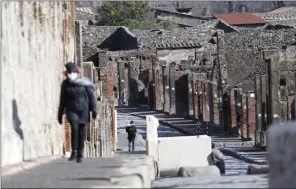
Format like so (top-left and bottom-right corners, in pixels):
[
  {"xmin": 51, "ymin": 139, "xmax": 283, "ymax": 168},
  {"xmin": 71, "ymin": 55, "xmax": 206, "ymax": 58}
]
[{"xmin": 169, "ymin": 62, "xmax": 176, "ymax": 115}]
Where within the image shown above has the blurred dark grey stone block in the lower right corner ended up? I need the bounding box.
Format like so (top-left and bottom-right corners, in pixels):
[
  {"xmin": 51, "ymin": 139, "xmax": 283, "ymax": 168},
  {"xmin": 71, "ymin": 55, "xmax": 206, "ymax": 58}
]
[{"xmin": 267, "ymin": 122, "xmax": 296, "ymax": 188}]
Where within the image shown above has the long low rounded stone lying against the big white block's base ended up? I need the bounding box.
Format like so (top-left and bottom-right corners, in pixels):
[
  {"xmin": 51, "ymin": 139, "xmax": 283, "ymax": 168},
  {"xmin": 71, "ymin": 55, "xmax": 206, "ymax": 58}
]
[{"xmin": 178, "ymin": 165, "xmax": 220, "ymax": 177}]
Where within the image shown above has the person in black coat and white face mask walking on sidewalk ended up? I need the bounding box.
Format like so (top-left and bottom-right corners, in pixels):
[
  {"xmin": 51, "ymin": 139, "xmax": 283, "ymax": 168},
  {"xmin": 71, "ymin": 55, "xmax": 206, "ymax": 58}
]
[{"xmin": 58, "ymin": 62, "xmax": 97, "ymax": 163}]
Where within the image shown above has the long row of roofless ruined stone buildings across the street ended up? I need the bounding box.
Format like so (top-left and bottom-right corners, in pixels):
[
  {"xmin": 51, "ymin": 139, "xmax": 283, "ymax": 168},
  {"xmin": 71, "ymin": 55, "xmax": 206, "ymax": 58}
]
[{"xmin": 83, "ymin": 10, "xmax": 296, "ymax": 148}]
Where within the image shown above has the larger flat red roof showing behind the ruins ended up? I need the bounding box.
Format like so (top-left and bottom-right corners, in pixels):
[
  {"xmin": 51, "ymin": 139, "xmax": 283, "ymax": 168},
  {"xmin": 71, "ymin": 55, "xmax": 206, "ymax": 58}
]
[{"xmin": 213, "ymin": 13, "xmax": 265, "ymax": 25}]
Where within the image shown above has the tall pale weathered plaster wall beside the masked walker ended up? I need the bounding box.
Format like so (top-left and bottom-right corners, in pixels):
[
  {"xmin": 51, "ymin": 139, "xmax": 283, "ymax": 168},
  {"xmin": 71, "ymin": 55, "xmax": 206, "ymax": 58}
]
[{"xmin": 1, "ymin": 1, "xmax": 75, "ymax": 166}]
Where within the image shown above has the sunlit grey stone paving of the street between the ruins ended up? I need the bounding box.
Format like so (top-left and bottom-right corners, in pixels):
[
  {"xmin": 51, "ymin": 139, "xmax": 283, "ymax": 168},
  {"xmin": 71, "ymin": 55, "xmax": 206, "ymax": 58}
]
[{"xmin": 118, "ymin": 108, "xmax": 268, "ymax": 188}]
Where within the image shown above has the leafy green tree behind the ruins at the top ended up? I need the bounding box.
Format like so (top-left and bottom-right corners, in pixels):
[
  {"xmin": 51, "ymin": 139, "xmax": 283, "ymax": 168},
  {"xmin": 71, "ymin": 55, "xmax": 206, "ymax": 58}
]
[{"xmin": 98, "ymin": 1, "xmax": 174, "ymax": 29}]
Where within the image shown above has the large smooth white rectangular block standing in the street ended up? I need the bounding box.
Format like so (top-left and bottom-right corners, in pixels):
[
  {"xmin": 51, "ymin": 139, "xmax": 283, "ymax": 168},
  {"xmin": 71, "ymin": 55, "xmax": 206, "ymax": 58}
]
[{"xmin": 158, "ymin": 135, "xmax": 212, "ymax": 176}]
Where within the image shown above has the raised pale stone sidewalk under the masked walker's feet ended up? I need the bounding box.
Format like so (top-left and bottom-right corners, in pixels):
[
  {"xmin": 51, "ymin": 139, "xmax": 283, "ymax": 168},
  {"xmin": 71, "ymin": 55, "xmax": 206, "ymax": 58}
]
[{"xmin": 2, "ymin": 154, "xmax": 155, "ymax": 188}]
